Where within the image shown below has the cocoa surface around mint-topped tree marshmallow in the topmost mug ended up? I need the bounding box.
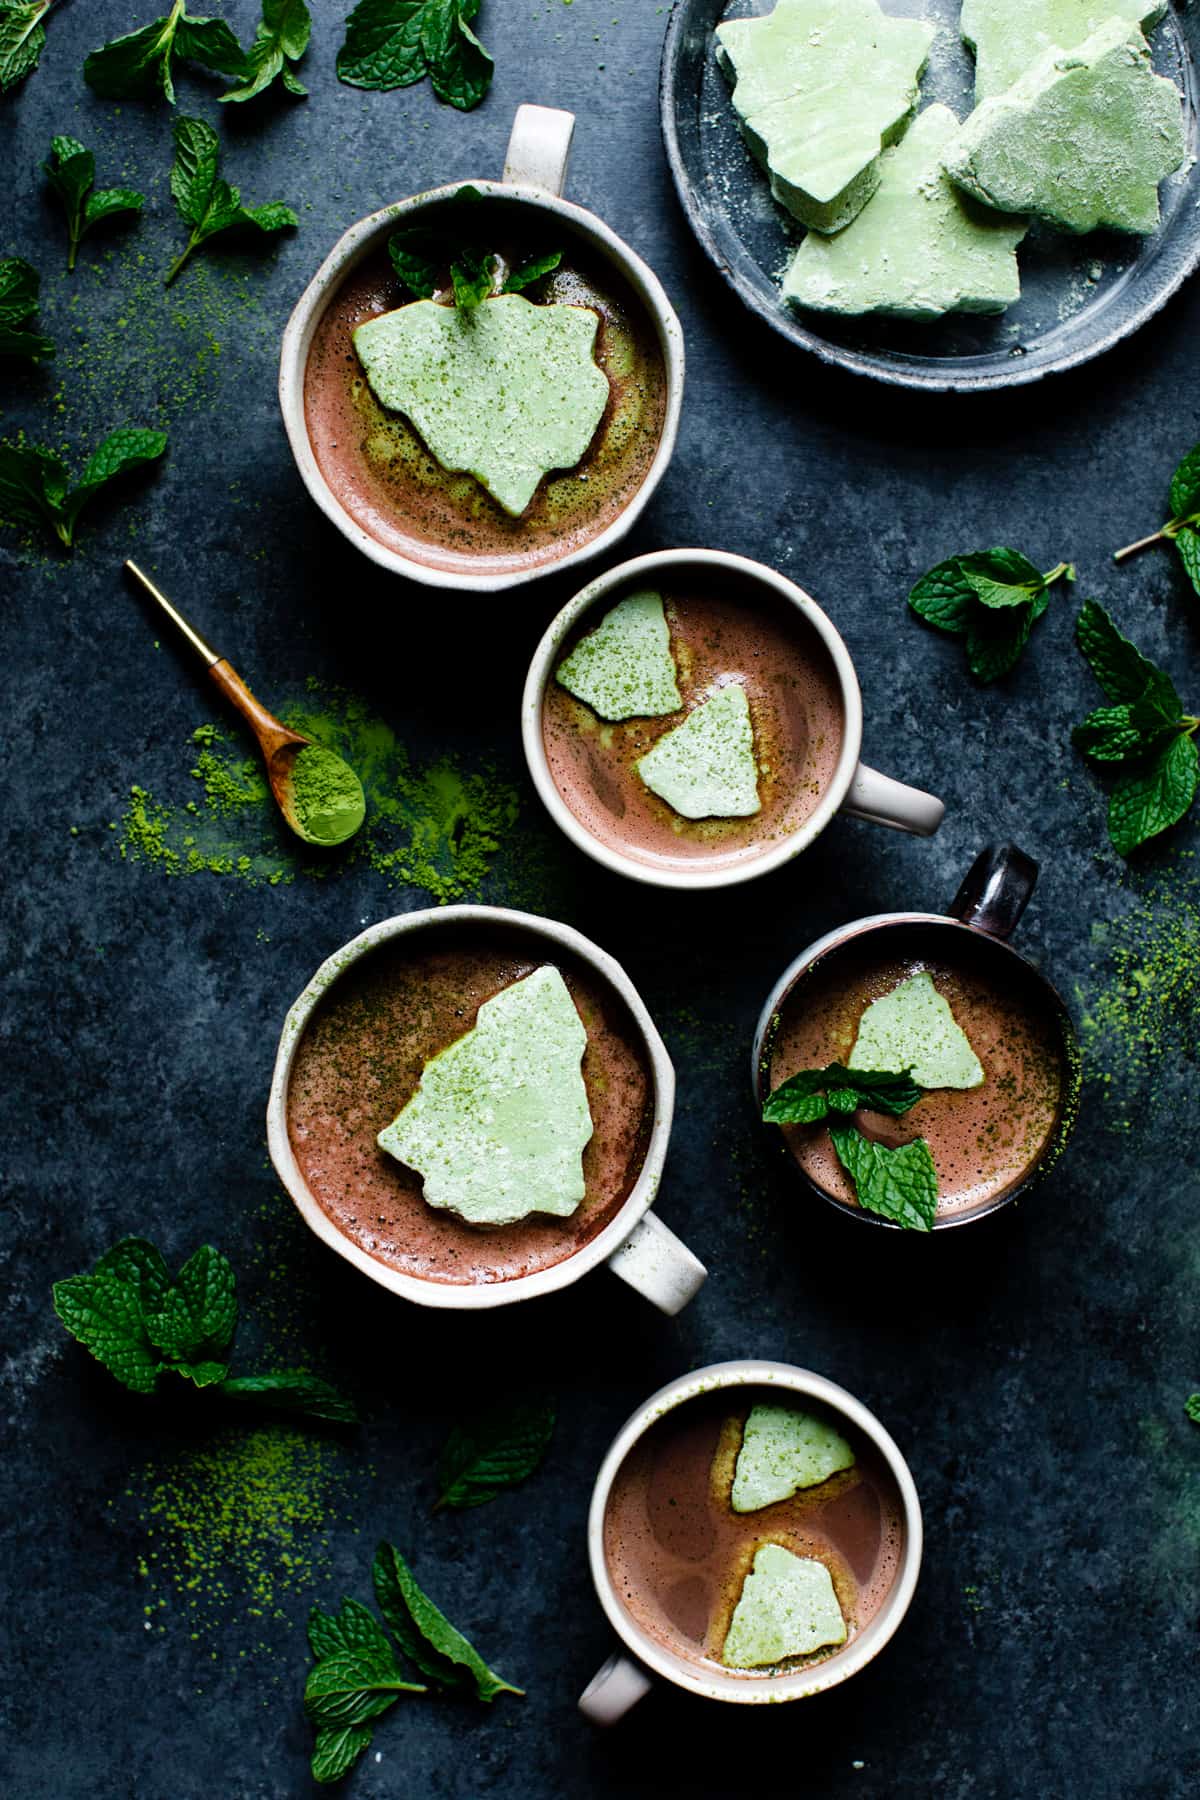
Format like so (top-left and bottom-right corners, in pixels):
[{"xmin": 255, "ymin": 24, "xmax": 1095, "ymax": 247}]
[{"xmin": 304, "ymin": 200, "xmax": 666, "ymax": 574}]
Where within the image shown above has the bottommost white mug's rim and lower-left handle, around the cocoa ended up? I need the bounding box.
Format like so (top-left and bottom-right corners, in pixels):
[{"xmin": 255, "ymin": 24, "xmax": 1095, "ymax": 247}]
[{"xmin": 579, "ymin": 1361, "xmax": 923, "ymax": 1724}]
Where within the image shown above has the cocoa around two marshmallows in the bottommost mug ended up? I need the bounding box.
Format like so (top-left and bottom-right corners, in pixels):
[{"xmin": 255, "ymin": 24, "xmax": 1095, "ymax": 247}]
[{"xmin": 604, "ymin": 1388, "xmax": 905, "ymax": 1679}]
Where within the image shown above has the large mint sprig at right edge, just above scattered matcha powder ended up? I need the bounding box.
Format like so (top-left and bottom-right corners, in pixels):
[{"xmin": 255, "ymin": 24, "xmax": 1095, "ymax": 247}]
[{"xmin": 1070, "ymin": 599, "xmax": 1200, "ymax": 857}]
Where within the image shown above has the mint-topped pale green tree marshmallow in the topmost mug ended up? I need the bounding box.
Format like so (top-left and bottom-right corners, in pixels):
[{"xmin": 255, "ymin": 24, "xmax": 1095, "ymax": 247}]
[{"xmin": 354, "ymin": 293, "xmax": 608, "ymax": 517}]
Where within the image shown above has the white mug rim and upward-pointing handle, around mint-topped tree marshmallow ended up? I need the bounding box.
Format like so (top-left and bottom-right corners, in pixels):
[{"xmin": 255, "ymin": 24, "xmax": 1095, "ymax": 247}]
[{"xmin": 279, "ymin": 106, "xmax": 684, "ymax": 592}]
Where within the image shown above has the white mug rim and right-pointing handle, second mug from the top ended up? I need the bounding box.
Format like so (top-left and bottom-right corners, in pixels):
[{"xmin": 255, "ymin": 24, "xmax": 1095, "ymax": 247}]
[{"xmin": 522, "ymin": 551, "xmax": 946, "ymax": 887}]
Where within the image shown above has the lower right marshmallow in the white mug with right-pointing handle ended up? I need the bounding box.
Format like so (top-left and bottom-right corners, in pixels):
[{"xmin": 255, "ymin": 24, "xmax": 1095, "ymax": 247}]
[{"xmin": 637, "ymin": 682, "xmax": 759, "ymax": 819}]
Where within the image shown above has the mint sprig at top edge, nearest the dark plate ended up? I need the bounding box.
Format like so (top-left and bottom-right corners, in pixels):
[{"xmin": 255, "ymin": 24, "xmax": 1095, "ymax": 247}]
[{"xmin": 338, "ymin": 0, "xmax": 493, "ymax": 112}]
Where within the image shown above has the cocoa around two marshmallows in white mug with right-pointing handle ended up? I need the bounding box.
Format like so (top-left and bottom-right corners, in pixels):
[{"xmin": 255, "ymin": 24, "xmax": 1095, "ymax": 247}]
[{"xmin": 542, "ymin": 567, "xmax": 846, "ymax": 869}]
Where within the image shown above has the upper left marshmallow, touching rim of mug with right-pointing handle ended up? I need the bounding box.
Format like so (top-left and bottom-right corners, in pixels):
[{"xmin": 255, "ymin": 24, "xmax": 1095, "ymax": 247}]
[{"xmin": 554, "ymin": 590, "xmax": 684, "ymax": 720}]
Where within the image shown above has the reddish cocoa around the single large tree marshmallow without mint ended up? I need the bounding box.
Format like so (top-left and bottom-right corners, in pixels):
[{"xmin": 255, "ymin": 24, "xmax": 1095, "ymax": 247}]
[{"xmin": 288, "ymin": 927, "xmax": 653, "ymax": 1283}]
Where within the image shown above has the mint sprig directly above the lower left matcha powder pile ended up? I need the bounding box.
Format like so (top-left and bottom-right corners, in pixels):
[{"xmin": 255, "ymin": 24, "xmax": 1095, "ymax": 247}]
[{"xmin": 54, "ymin": 1238, "xmax": 356, "ymax": 1424}]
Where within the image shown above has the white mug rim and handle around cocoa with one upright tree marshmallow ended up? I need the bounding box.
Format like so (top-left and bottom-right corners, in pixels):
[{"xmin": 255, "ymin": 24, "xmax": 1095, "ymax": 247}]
[{"xmin": 266, "ymin": 905, "xmax": 707, "ymax": 1314}]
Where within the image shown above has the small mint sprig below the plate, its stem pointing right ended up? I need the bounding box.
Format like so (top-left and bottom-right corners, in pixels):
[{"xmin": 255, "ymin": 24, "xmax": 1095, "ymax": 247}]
[{"xmin": 909, "ymin": 545, "xmax": 1076, "ymax": 682}]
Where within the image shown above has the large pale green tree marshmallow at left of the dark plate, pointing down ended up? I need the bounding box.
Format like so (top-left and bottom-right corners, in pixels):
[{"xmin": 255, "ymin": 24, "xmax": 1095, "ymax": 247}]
[{"xmin": 716, "ymin": 0, "xmax": 934, "ymax": 232}]
